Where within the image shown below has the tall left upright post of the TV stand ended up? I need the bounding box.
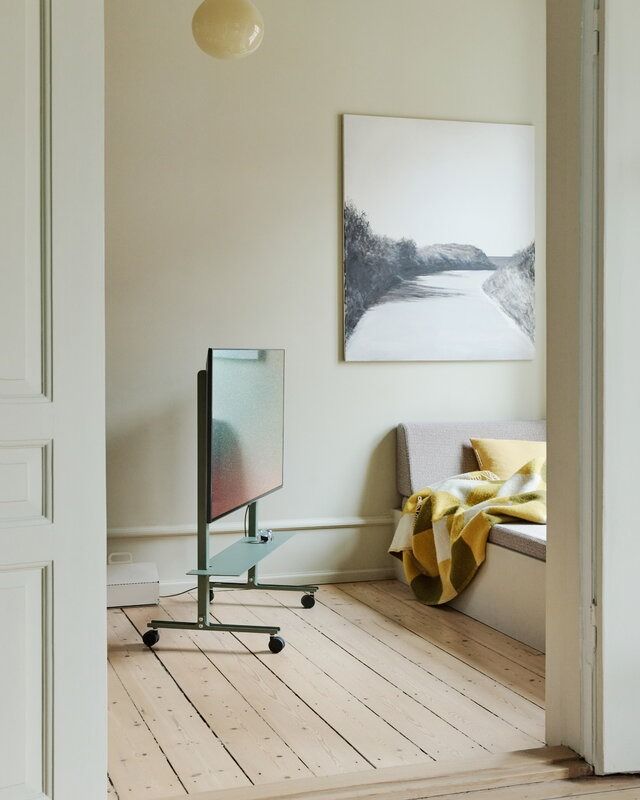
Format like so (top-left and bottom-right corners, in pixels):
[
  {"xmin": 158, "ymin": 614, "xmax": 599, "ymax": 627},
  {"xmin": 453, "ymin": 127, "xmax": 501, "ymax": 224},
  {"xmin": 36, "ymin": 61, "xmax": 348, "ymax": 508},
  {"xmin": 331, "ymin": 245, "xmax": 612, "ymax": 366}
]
[{"xmin": 197, "ymin": 370, "xmax": 211, "ymax": 625}]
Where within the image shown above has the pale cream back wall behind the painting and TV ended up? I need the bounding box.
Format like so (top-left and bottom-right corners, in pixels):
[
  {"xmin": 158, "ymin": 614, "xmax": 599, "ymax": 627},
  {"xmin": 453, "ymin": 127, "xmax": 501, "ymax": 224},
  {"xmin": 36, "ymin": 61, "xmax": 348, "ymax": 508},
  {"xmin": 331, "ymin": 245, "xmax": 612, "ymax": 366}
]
[{"xmin": 106, "ymin": 0, "xmax": 545, "ymax": 580}]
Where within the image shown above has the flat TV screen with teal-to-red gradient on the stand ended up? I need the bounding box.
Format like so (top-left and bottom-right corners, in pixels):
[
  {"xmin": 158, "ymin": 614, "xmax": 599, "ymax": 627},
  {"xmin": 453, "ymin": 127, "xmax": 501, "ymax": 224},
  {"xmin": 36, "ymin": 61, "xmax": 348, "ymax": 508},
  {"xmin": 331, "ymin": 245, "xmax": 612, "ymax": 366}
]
[{"xmin": 207, "ymin": 349, "xmax": 284, "ymax": 522}]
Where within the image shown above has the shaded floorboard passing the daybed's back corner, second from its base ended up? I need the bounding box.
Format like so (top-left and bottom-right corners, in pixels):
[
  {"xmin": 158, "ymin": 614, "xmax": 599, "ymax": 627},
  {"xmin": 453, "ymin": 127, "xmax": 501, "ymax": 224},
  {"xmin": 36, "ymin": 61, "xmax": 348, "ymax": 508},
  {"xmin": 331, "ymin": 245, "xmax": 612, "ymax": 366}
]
[{"xmin": 341, "ymin": 583, "xmax": 544, "ymax": 707}]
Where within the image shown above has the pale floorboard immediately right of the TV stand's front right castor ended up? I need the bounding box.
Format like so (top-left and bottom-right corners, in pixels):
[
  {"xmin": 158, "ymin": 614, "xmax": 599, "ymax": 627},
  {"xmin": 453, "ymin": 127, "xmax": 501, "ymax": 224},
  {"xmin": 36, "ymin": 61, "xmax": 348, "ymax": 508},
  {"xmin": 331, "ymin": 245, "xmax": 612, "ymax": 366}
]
[{"xmin": 214, "ymin": 592, "xmax": 482, "ymax": 759}]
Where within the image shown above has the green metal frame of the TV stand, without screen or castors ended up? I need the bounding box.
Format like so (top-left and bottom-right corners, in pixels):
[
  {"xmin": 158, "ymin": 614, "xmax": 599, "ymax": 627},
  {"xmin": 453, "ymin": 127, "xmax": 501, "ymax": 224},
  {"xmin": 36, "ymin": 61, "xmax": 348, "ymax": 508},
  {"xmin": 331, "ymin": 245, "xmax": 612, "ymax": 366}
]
[{"xmin": 147, "ymin": 370, "xmax": 318, "ymax": 636}]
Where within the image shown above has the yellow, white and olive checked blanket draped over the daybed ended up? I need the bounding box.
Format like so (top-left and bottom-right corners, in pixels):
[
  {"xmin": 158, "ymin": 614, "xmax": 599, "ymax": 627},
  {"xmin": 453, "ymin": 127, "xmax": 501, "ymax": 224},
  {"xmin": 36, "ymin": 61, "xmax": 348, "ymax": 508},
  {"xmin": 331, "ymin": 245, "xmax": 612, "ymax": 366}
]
[{"xmin": 389, "ymin": 458, "xmax": 547, "ymax": 605}]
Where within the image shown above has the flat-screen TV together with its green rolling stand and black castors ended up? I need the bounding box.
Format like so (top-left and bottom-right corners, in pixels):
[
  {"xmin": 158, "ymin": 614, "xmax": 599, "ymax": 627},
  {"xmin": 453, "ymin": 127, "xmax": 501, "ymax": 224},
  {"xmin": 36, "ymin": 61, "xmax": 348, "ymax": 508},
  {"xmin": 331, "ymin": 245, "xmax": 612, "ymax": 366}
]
[{"xmin": 142, "ymin": 348, "xmax": 318, "ymax": 653}]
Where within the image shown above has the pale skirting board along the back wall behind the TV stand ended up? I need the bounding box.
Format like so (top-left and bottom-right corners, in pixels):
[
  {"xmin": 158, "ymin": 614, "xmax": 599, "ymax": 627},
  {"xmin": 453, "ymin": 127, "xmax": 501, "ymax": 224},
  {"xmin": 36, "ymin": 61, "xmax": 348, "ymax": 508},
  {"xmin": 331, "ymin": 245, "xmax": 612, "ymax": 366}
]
[{"xmin": 107, "ymin": 517, "xmax": 395, "ymax": 595}]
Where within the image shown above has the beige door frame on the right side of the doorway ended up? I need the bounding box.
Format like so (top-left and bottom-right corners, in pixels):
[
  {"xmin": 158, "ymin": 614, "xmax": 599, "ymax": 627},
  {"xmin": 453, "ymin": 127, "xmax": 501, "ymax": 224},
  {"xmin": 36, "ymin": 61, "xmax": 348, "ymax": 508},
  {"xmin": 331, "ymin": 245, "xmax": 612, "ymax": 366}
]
[{"xmin": 547, "ymin": 0, "xmax": 605, "ymax": 770}]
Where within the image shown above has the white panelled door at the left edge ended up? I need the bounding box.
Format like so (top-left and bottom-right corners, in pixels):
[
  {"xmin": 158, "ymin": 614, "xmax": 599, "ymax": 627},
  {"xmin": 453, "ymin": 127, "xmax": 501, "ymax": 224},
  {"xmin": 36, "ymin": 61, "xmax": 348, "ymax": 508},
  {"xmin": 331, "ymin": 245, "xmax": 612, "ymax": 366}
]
[{"xmin": 0, "ymin": 0, "xmax": 106, "ymax": 800}]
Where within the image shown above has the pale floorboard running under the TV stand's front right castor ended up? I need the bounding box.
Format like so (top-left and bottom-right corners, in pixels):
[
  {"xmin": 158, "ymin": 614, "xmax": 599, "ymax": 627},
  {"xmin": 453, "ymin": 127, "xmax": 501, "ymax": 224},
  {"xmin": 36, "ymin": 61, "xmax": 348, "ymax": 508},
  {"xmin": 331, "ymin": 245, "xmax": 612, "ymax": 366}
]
[{"xmin": 200, "ymin": 593, "xmax": 428, "ymax": 774}]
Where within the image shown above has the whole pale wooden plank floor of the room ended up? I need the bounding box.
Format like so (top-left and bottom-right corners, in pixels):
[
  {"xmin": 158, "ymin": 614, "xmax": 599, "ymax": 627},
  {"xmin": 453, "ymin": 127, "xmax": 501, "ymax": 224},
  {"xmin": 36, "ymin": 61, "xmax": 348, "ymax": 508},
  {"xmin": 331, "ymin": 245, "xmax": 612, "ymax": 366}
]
[{"xmin": 109, "ymin": 581, "xmax": 640, "ymax": 800}]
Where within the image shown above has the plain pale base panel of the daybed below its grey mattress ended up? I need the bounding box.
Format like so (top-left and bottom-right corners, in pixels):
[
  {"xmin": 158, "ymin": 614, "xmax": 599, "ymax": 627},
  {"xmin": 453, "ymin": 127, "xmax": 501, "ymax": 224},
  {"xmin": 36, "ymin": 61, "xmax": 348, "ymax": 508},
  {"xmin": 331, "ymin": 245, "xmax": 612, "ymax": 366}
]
[{"xmin": 394, "ymin": 510, "xmax": 546, "ymax": 652}]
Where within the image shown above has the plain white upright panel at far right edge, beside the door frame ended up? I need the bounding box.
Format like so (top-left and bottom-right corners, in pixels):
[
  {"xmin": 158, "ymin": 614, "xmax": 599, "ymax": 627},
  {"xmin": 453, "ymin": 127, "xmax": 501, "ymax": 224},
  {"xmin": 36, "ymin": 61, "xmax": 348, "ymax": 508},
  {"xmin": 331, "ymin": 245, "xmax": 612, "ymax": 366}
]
[{"xmin": 599, "ymin": 0, "xmax": 640, "ymax": 772}]
